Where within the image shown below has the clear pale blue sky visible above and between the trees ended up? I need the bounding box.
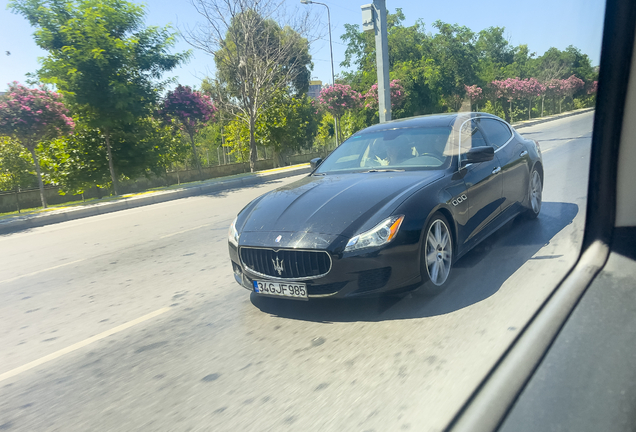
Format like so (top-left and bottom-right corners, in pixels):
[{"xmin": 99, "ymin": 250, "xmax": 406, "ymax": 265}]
[{"xmin": 0, "ymin": 0, "xmax": 605, "ymax": 91}]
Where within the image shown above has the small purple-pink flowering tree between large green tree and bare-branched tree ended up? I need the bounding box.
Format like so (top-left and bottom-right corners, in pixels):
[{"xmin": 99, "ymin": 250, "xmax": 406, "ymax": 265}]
[{"xmin": 159, "ymin": 85, "xmax": 217, "ymax": 175}]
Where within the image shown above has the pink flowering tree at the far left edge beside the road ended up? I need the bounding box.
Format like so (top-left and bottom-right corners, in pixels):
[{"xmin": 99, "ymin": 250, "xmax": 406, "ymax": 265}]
[{"xmin": 0, "ymin": 81, "xmax": 75, "ymax": 208}]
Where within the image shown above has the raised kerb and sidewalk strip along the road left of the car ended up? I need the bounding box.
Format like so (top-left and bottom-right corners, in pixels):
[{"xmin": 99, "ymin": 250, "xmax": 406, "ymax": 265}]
[{"xmin": 0, "ymin": 163, "xmax": 311, "ymax": 235}]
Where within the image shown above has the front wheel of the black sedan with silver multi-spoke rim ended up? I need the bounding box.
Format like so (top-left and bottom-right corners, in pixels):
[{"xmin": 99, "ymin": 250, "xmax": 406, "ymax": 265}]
[{"xmin": 420, "ymin": 213, "xmax": 453, "ymax": 294}]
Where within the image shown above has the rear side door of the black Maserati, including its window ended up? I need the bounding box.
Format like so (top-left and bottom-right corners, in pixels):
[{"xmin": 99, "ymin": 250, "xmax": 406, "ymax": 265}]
[{"xmin": 477, "ymin": 118, "xmax": 529, "ymax": 211}]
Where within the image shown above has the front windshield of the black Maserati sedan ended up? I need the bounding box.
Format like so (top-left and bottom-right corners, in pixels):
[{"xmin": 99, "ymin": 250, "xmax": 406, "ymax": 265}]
[{"xmin": 316, "ymin": 127, "xmax": 455, "ymax": 174}]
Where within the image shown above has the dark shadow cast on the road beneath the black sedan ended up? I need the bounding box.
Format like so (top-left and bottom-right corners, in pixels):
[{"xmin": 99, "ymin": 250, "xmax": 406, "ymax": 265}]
[{"xmin": 250, "ymin": 202, "xmax": 582, "ymax": 323}]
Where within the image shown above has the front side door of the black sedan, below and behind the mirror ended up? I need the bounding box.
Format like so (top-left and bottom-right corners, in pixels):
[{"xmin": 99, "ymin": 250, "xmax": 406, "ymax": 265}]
[{"xmin": 460, "ymin": 119, "xmax": 503, "ymax": 245}]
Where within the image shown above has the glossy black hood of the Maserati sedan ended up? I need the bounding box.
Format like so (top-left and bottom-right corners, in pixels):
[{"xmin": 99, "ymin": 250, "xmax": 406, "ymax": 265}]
[{"xmin": 237, "ymin": 171, "xmax": 444, "ymax": 246}]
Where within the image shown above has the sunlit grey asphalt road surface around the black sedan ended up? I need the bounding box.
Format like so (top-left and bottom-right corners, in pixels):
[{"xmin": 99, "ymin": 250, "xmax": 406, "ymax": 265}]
[{"xmin": 0, "ymin": 113, "xmax": 593, "ymax": 431}]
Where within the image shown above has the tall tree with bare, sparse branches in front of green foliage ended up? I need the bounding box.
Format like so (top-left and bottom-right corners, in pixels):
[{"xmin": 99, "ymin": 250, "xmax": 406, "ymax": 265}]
[{"xmin": 188, "ymin": 0, "xmax": 313, "ymax": 171}]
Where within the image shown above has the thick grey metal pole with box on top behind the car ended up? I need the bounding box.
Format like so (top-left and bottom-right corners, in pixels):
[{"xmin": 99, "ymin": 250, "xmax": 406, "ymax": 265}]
[{"xmin": 361, "ymin": 0, "xmax": 391, "ymax": 123}]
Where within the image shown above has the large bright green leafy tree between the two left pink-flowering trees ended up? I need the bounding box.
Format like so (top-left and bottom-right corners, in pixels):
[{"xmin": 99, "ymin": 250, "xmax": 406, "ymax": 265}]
[{"xmin": 9, "ymin": 0, "xmax": 189, "ymax": 195}]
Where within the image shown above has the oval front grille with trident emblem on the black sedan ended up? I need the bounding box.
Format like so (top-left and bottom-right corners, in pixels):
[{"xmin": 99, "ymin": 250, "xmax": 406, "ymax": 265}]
[{"xmin": 241, "ymin": 247, "xmax": 331, "ymax": 279}]
